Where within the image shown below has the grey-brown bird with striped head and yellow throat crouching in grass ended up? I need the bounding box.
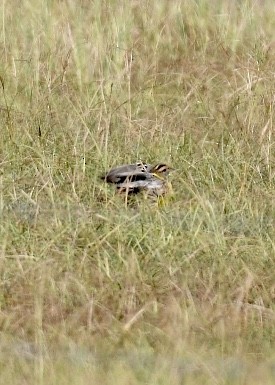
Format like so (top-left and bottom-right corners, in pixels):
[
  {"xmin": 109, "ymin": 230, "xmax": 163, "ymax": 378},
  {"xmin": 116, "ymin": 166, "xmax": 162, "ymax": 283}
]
[{"xmin": 101, "ymin": 162, "xmax": 174, "ymax": 199}]
